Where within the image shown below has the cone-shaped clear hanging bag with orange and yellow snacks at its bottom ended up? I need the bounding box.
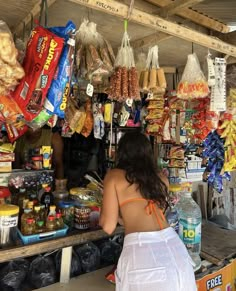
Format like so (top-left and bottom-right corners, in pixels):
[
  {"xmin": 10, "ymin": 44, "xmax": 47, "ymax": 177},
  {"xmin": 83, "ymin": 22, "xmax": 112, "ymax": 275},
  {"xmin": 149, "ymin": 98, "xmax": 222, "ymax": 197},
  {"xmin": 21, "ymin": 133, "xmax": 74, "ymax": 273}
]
[{"xmin": 177, "ymin": 53, "xmax": 209, "ymax": 100}]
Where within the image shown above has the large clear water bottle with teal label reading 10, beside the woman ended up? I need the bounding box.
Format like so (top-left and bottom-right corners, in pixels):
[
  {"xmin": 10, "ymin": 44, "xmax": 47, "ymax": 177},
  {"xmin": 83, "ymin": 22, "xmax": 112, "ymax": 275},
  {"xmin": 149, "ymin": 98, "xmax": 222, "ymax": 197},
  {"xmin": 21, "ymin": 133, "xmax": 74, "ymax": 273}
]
[{"xmin": 176, "ymin": 190, "xmax": 202, "ymax": 271}]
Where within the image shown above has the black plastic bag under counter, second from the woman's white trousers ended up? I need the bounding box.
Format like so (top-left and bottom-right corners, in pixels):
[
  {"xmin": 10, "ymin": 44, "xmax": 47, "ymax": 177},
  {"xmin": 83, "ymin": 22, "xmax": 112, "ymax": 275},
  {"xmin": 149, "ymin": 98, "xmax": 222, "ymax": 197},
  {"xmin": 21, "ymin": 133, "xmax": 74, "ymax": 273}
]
[{"xmin": 75, "ymin": 242, "xmax": 101, "ymax": 273}]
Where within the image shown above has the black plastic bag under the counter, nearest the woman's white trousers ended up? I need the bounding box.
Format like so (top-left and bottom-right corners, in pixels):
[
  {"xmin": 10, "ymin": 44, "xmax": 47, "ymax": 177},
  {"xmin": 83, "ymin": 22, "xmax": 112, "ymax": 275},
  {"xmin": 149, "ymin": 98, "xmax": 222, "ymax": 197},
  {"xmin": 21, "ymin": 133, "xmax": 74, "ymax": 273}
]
[{"xmin": 99, "ymin": 240, "xmax": 122, "ymax": 265}]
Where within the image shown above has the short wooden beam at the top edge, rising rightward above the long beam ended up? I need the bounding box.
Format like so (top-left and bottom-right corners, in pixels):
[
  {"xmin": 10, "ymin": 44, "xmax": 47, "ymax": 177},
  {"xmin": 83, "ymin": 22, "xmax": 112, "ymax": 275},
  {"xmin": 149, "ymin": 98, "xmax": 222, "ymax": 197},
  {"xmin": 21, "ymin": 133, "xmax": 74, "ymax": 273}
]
[{"xmin": 159, "ymin": 0, "xmax": 204, "ymax": 17}]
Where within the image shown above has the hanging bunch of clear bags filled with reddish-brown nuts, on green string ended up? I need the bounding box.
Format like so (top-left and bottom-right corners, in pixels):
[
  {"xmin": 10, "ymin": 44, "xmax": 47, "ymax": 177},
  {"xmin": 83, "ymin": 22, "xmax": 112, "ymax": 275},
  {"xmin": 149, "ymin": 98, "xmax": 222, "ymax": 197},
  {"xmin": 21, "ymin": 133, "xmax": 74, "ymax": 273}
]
[{"xmin": 109, "ymin": 20, "xmax": 140, "ymax": 102}]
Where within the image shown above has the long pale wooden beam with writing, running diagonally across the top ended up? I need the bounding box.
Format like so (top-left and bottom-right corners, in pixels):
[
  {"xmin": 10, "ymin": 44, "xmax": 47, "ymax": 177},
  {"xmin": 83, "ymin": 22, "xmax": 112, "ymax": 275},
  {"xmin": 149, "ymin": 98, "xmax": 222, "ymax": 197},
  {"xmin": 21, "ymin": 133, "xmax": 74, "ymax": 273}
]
[{"xmin": 70, "ymin": 0, "xmax": 236, "ymax": 56}]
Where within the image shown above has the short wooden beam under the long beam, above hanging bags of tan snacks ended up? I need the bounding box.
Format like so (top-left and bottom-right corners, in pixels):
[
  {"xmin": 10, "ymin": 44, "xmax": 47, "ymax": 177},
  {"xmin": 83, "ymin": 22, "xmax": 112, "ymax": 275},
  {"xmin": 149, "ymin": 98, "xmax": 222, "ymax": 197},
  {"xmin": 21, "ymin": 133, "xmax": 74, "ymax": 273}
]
[{"xmin": 131, "ymin": 32, "xmax": 172, "ymax": 49}]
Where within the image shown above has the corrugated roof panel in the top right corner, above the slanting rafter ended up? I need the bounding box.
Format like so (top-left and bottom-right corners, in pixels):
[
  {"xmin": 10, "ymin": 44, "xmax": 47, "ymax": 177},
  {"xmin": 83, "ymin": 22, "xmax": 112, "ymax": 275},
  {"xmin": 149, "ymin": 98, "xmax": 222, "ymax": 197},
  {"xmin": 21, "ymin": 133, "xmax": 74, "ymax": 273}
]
[{"xmin": 192, "ymin": 0, "xmax": 236, "ymax": 26}]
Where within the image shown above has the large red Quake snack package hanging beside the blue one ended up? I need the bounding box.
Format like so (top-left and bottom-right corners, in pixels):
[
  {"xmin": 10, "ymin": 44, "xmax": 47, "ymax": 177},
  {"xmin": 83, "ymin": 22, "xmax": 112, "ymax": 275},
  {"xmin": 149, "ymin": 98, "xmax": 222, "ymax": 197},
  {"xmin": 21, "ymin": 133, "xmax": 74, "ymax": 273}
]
[{"xmin": 13, "ymin": 26, "xmax": 64, "ymax": 121}]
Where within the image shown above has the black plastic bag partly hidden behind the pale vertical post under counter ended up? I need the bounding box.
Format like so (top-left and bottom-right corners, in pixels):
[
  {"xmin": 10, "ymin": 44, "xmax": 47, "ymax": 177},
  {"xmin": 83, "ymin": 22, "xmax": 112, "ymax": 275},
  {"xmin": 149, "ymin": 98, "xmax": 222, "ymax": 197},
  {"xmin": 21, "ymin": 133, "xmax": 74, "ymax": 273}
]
[{"xmin": 55, "ymin": 250, "xmax": 82, "ymax": 278}]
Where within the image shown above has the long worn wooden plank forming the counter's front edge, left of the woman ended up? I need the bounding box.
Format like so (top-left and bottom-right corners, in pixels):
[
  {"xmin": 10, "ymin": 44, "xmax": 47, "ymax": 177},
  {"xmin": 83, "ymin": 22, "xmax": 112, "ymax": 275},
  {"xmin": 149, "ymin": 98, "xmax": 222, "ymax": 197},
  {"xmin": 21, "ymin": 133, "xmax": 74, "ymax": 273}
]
[{"xmin": 0, "ymin": 226, "xmax": 124, "ymax": 263}]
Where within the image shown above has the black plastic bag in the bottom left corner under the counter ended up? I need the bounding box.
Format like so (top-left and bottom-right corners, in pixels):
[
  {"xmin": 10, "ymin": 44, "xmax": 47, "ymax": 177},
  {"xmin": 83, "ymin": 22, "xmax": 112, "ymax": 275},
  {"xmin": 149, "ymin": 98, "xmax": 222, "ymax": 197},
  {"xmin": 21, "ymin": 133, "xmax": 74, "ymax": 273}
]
[{"xmin": 0, "ymin": 259, "xmax": 30, "ymax": 291}]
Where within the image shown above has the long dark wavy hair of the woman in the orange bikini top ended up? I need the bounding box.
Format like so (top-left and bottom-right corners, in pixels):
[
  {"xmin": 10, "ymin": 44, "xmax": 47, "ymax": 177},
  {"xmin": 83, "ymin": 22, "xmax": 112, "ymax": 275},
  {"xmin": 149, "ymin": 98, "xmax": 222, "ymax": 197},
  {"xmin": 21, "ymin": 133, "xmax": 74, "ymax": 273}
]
[{"xmin": 117, "ymin": 132, "xmax": 168, "ymax": 208}]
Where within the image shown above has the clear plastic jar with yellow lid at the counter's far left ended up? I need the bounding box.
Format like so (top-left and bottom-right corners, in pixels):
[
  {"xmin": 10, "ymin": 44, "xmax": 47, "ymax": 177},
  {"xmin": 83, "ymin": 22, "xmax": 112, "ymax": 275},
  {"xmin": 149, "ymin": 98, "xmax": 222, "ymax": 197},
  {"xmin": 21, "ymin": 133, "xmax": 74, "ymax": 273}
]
[{"xmin": 0, "ymin": 204, "xmax": 19, "ymax": 247}]
